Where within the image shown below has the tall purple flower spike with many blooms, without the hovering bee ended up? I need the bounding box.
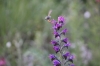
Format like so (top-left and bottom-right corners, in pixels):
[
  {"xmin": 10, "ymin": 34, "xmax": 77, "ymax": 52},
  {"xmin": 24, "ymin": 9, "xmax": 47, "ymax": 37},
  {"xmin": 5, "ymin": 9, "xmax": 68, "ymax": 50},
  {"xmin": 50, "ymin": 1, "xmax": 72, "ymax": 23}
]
[{"xmin": 49, "ymin": 16, "xmax": 74, "ymax": 66}]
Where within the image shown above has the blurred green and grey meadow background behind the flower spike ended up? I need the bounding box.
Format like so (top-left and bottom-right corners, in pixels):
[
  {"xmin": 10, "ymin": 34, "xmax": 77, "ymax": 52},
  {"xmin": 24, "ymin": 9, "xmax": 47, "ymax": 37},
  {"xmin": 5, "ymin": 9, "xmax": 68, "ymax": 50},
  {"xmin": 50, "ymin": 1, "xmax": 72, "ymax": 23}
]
[{"xmin": 0, "ymin": 0, "xmax": 100, "ymax": 66}]
